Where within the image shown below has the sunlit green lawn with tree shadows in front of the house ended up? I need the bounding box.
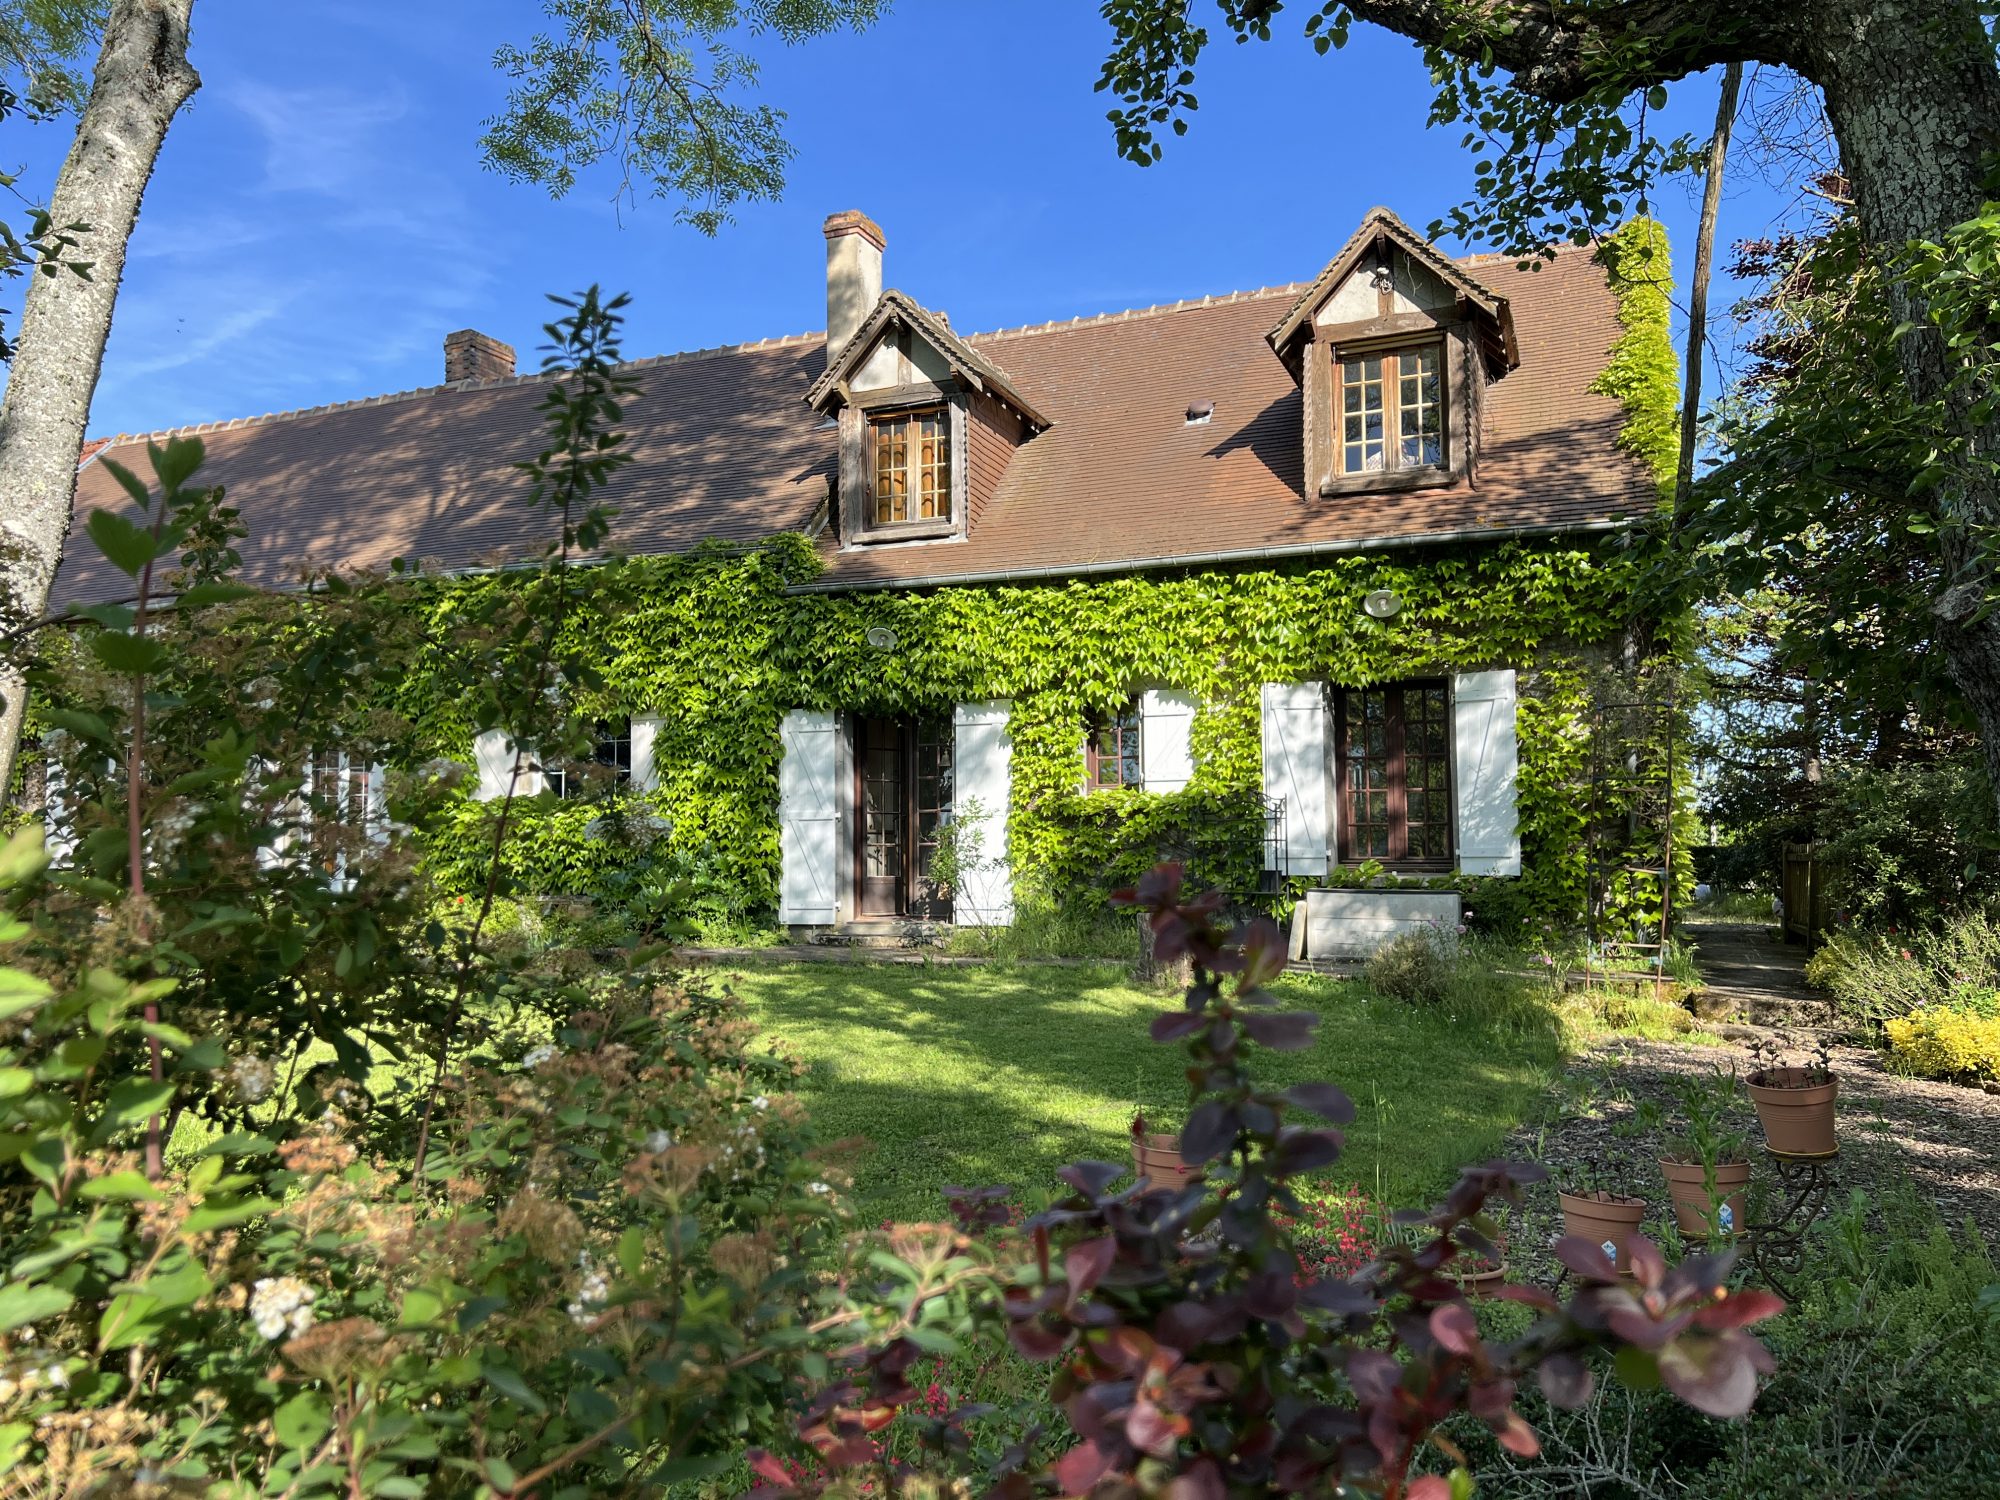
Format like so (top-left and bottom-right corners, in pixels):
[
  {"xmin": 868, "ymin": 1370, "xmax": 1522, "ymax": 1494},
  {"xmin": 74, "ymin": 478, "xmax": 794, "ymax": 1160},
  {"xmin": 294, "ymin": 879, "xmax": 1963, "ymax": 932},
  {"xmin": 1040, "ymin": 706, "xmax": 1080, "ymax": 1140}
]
[{"xmin": 734, "ymin": 964, "xmax": 1560, "ymax": 1218}]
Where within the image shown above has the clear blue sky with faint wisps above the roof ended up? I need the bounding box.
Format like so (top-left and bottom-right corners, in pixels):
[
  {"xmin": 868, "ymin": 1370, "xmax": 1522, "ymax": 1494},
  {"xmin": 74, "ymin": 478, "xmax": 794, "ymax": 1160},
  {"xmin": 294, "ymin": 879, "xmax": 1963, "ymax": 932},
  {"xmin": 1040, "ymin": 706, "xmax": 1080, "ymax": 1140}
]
[{"xmin": 0, "ymin": 0, "xmax": 1784, "ymax": 432}]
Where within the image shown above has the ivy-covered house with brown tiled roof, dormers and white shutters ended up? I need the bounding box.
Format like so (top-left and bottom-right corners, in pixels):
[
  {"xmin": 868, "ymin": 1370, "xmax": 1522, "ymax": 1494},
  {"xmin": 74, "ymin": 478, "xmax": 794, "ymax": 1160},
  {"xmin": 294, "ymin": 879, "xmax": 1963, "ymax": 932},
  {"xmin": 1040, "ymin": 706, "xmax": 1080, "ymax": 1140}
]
[{"xmin": 58, "ymin": 208, "xmax": 1672, "ymax": 952}]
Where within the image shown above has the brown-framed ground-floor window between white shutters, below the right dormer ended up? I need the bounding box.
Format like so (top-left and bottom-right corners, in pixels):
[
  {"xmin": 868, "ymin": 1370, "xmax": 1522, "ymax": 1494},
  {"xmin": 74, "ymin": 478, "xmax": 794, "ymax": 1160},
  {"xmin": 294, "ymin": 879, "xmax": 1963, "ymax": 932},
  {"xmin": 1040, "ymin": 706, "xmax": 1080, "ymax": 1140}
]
[{"xmin": 1336, "ymin": 682, "xmax": 1452, "ymax": 868}]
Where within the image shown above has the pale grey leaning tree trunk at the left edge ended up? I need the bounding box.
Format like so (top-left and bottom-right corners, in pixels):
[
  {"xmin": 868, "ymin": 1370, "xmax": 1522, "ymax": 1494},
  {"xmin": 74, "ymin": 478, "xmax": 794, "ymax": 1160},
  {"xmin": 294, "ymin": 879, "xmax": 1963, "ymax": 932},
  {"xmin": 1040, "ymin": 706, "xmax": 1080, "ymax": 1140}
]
[{"xmin": 0, "ymin": 0, "xmax": 202, "ymax": 798}]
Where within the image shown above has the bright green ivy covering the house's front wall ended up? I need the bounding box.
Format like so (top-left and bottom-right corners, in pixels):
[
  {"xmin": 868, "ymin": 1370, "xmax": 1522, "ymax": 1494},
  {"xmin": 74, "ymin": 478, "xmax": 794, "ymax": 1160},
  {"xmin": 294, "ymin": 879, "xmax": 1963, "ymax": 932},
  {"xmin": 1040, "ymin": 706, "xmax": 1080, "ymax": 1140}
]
[{"xmin": 400, "ymin": 538, "xmax": 1638, "ymax": 916}]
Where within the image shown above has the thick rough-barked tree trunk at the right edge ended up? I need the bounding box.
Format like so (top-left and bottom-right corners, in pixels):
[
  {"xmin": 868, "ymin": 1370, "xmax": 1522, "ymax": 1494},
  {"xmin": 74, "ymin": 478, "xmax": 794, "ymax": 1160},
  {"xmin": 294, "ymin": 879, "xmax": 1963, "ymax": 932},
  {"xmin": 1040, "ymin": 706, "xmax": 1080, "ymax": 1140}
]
[{"xmin": 1802, "ymin": 0, "xmax": 2000, "ymax": 800}]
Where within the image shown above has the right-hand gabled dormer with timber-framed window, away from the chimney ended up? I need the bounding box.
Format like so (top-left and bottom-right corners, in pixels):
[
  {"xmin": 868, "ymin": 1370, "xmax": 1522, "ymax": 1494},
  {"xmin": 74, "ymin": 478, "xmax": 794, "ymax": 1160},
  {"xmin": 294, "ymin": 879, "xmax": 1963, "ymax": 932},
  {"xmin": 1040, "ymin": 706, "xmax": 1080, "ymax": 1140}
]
[{"xmin": 1266, "ymin": 208, "xmax": 1520, "ymax": 500}]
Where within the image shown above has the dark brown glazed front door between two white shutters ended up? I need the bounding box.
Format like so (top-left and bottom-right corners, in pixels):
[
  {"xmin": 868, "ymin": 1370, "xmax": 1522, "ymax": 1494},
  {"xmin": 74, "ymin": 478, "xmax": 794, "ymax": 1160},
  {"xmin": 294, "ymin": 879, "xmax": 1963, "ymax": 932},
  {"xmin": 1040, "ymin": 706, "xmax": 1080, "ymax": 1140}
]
[{"xmin": 854, "ymin": 716, "xmax": 952, "ymax": 922}]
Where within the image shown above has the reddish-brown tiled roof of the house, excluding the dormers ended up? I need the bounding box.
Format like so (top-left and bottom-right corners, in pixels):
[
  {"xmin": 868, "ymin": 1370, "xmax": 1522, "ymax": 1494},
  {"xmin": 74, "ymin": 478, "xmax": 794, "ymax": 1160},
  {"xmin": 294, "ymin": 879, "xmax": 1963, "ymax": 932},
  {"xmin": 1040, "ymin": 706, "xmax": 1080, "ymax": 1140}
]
[{"xmin": 54, "ymin": 250, "xmax": 1654, "ymax": 602}]
